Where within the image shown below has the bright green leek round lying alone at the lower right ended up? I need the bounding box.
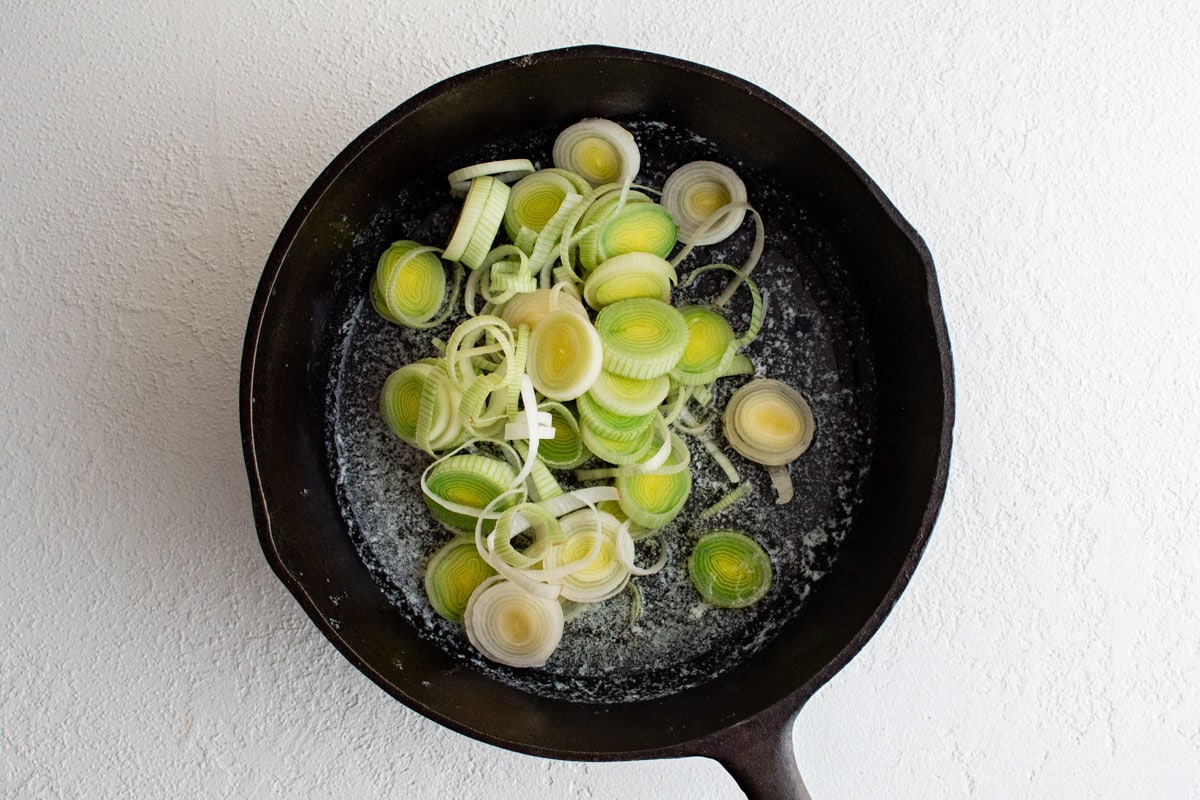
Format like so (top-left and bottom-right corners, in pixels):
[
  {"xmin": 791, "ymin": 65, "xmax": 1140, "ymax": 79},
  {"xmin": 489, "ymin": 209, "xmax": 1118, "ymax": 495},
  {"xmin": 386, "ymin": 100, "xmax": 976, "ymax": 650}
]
[{"xmin": 688, "ymin": 530, "xmax": 772, "ymax": 608}]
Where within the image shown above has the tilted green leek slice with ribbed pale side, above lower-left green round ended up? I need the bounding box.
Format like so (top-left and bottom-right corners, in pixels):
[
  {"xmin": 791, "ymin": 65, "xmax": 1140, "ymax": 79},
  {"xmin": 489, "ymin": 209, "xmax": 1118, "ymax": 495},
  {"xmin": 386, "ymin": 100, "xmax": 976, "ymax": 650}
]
[{"xmin": 421, "ymin": 455, "xmax": 517, "ymax": 533}]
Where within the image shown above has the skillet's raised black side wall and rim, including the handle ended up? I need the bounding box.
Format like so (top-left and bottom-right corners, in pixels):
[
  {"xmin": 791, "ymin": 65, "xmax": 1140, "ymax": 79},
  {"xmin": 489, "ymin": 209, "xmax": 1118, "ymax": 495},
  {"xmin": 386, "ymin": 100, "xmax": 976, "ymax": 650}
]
[{"xmin": 241, "ymin": 47, "xmax": 953, "ymax": 798}]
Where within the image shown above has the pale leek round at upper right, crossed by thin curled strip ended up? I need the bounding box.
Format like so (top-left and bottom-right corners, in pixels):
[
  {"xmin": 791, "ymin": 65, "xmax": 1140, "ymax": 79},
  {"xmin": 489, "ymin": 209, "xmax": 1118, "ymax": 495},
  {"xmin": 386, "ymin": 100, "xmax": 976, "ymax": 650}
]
[{"xmin": 662, "ymin": 161, "xmax": 746, "ymax": 245}]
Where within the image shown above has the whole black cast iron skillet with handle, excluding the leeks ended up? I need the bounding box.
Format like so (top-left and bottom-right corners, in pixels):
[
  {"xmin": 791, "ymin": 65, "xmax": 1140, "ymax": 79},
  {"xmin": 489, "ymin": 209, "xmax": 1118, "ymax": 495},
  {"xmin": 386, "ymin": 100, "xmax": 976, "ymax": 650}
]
[{"xmin": 241, "ymin": 47, "xmax": 953, "ymax": 798}]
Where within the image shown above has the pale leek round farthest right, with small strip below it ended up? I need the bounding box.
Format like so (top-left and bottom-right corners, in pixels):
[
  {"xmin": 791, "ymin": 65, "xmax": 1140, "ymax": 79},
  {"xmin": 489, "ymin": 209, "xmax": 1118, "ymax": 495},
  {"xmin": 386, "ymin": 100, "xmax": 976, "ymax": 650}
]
[{"xmin": 724, "ymin": 378, "xmax": 815, "ymax": 505}]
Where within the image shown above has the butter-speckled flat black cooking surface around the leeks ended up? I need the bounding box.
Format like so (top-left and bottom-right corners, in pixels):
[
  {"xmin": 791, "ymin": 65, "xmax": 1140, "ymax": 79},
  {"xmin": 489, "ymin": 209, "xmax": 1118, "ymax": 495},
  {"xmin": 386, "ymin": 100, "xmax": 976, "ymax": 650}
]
[{"xmin": 328, "ymin": 115, "xmax": 876, "ymax": 703}]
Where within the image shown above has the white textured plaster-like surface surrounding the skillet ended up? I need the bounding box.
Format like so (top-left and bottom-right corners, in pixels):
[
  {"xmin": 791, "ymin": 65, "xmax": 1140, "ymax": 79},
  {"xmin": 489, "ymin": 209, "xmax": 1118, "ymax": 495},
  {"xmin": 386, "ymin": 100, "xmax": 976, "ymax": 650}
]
[{"xmin": 0, "ymin": 0, "xmax": 1200, "ymax": 800}]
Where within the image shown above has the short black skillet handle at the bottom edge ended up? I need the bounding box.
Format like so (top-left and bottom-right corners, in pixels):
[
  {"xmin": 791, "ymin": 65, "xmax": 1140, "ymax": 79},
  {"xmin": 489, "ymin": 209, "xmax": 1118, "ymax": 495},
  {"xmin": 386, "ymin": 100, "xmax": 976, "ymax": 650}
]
[{"xmin": 703, "ymin": 714, "xmax": 812, "ymax": 800}]
